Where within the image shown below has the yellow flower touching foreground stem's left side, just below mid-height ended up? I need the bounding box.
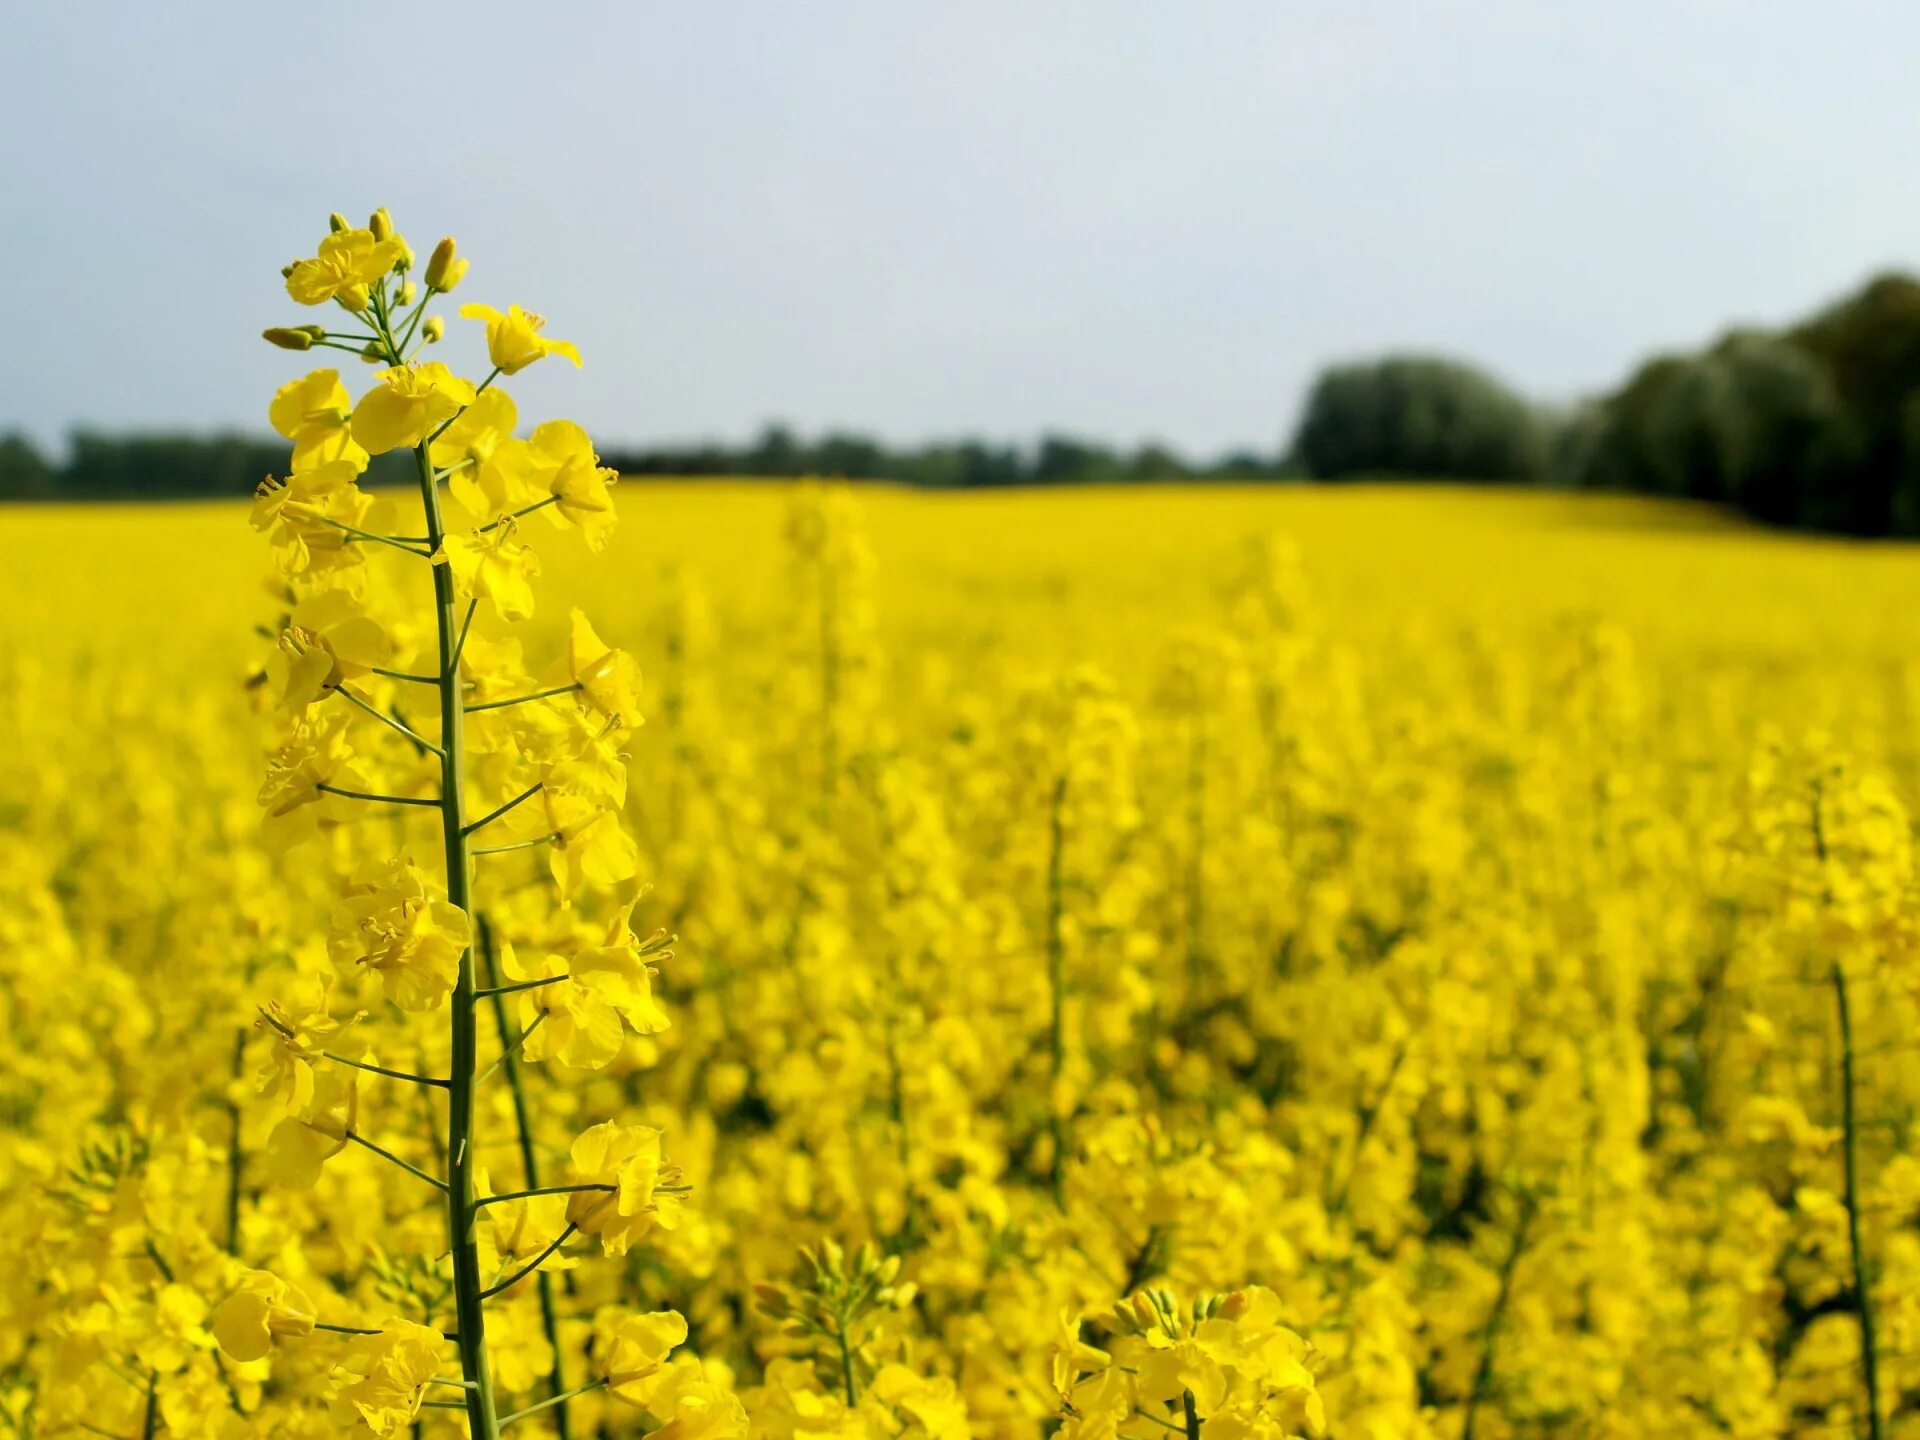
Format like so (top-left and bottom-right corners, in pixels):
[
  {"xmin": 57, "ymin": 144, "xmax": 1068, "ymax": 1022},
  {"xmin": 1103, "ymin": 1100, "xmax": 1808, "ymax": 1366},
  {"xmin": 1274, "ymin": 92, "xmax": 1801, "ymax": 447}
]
[{"xmin": 326, "ymin": 860, "xmax": 472, "ymax": 1012}]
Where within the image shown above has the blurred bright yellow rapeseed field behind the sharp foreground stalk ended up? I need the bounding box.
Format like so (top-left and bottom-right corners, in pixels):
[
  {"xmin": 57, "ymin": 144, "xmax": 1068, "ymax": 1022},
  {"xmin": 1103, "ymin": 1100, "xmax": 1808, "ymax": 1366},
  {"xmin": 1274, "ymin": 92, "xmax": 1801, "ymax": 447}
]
[{"xmin": 0, "ymin": 484, "xmax": 1920, "ymax": 1440}]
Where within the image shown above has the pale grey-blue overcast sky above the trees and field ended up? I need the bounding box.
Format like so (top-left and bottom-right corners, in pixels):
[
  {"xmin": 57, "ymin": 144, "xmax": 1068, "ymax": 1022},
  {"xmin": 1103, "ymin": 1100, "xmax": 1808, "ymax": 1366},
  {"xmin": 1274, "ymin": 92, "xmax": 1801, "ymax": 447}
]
[{"xmin": 0, "ymin": 0, "xmax": 1920, "ymax": 453}]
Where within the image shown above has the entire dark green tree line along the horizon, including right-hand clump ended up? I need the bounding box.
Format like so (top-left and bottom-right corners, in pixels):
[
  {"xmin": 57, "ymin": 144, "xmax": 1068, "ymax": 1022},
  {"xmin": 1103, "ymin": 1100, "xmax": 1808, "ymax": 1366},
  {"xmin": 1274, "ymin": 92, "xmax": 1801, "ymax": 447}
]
[{"xmin": 11, "ymin": 275, "xmax": 1920, "ymax": 536}]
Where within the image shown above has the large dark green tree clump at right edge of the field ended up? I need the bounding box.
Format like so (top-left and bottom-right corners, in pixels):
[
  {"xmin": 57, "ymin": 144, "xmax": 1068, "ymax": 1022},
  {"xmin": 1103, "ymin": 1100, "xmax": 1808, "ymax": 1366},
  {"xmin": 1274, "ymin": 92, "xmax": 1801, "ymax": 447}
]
[{"xmin": 1292, "ymin": 275, "xmax": 1920, "ymax": 536}]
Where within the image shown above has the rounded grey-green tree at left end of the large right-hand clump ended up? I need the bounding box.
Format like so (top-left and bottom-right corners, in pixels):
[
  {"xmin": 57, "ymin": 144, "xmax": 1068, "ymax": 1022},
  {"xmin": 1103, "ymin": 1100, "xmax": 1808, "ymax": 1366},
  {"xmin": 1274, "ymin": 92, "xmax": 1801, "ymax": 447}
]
[{"xmin": 1292, "ymin": 355, "xmax": 1548, "ymax": 480}]
